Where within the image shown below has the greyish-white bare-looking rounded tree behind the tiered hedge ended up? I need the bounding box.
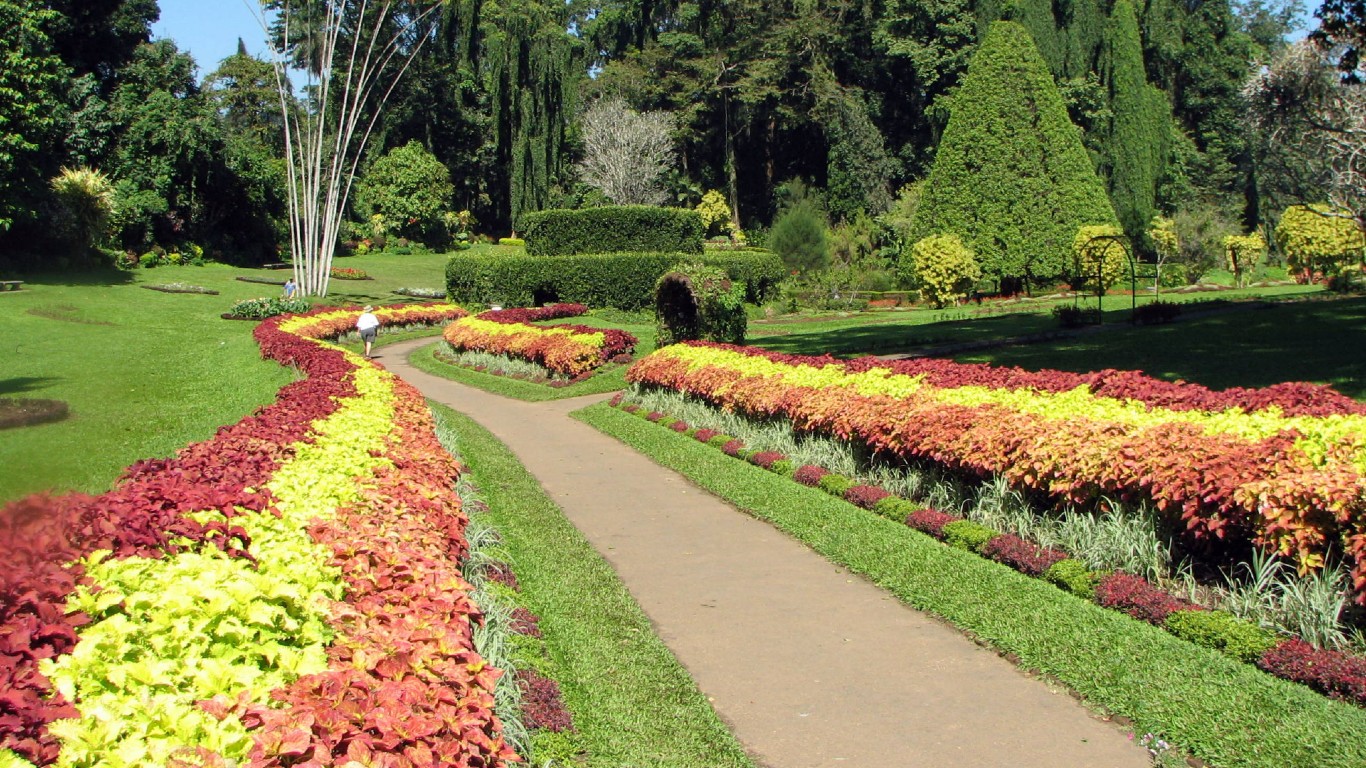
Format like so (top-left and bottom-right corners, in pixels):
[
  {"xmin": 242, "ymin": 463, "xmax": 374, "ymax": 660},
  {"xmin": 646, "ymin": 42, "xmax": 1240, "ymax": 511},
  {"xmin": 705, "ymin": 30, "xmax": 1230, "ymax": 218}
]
[{"xmin": 579, "ymin": 98, "xmax": 673, "ymax": 205}]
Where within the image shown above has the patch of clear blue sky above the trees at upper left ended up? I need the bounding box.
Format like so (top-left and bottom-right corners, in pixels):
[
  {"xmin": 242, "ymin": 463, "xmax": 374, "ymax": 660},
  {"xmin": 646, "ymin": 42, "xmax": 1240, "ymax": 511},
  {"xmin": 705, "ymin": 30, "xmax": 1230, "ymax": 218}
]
[{"xmin": 152, "ymin": 0, "xmax": 266, "ymax": 79}]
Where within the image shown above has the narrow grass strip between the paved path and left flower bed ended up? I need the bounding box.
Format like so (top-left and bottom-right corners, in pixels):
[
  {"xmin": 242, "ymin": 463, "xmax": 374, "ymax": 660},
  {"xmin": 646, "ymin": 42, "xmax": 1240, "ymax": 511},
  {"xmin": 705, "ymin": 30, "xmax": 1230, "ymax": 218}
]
[{"xmin": 429, "ymin": 402, "xmax": 753, "ymax": 768}]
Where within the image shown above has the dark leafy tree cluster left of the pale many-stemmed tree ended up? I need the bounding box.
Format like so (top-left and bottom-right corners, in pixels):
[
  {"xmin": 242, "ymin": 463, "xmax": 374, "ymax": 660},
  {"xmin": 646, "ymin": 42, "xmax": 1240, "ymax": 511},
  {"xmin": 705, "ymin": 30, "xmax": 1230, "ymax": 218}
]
[{"xmin": 0, "ymin": 0, "xmax": 283, "ymax": 266}]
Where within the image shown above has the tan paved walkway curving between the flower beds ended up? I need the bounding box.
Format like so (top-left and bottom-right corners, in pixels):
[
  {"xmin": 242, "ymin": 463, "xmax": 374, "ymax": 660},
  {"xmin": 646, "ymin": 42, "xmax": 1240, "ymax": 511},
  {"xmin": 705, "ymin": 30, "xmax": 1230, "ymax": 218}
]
[{"xmin": 378, "ymin": 339, "xmax": 1149, "ymax": 768}]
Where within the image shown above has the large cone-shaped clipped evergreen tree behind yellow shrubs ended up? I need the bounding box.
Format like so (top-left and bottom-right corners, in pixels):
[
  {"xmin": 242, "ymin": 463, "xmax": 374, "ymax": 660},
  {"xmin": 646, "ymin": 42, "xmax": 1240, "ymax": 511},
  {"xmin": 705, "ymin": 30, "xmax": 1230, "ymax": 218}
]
[{"xmin": 910, "ymin": 22, "xmax": 1119, "ymax": 283}]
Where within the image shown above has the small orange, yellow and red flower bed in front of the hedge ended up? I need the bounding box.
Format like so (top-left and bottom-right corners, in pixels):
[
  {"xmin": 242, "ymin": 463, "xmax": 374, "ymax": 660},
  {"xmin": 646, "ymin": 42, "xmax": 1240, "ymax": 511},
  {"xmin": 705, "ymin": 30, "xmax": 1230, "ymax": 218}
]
[{"xmin": 444, "ymin": 305, "xmax": 637, "ymax": 377}]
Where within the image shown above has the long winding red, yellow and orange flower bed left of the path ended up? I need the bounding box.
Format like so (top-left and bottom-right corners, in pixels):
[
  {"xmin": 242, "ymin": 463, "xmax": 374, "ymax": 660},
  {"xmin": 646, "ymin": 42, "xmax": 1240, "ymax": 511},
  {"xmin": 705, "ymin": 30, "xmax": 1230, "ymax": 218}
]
[{"xmin": 0, "ymin": 306, "xmax": 515, "ymax": 767}]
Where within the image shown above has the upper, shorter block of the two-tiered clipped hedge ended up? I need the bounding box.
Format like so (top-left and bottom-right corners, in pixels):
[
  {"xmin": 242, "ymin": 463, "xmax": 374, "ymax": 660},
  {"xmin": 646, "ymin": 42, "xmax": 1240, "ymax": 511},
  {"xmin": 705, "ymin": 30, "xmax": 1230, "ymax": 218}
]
[{"xmin": 518, "ymin": 205, "xmax": 706, "ymax": 256}]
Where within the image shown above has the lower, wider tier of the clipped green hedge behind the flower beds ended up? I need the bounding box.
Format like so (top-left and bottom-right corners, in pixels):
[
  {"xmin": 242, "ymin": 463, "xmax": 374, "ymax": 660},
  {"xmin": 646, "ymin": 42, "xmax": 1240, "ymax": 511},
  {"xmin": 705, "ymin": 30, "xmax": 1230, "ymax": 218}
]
[{"xmin": 445, "ymin": 251, "xmax": 787, "ymax": 309}]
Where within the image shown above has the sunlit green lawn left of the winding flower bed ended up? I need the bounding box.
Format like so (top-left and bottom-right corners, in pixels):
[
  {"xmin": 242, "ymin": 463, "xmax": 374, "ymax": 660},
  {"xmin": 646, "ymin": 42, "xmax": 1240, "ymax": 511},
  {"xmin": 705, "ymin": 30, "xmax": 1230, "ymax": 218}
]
[{"xmin": 0, "ymin": 248, "xmax": 464, "ymax": 502}]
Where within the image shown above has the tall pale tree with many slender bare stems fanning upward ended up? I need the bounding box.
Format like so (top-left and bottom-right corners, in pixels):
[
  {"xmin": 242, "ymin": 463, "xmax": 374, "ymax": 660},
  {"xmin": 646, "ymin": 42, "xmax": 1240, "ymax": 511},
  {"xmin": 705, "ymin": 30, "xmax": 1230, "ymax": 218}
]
[{"xmin": 243, "ymin": 0, "xmax": 443, "ymax": 297}]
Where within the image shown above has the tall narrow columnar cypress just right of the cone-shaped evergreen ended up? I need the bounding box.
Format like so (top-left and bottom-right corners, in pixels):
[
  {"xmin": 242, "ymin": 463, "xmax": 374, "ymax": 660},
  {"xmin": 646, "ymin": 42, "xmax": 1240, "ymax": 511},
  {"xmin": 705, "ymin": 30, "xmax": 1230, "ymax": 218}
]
[{"xmin": 1101, "ymin": 0, "xmax": 1172, "ymax": 242}]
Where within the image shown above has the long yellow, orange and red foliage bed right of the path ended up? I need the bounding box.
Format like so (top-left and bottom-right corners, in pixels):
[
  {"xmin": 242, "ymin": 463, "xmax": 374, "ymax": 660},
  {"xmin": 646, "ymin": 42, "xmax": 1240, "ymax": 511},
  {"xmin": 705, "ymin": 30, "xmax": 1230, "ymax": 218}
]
[{"xmin": 627, "ymin": 343, "xmax": 1366, "ymax": 603}]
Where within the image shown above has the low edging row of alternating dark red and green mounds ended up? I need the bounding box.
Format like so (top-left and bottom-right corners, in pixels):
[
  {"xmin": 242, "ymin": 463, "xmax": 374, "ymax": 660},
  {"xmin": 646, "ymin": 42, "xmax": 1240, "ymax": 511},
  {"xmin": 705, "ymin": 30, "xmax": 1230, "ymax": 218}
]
[{"xmin": 612, "ymin": 394, "xmax": 1366, "ymax": 707}]
